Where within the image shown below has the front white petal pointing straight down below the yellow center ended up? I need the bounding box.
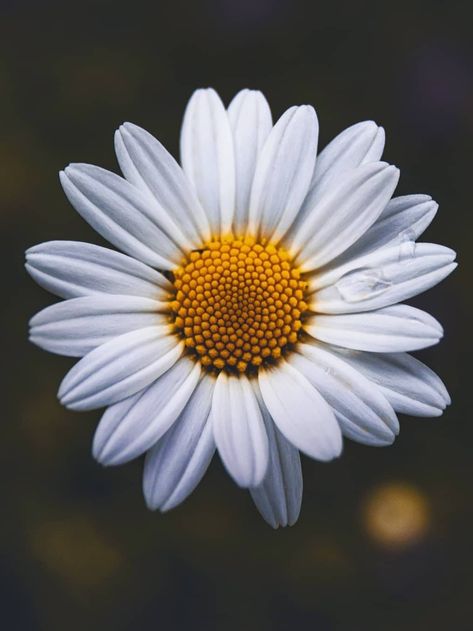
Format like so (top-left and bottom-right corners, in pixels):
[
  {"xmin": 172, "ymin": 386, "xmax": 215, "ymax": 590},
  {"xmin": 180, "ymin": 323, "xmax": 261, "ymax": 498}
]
[{"xmin": 211, "ymin": 372, "xmax": 269, "ymax": 487}]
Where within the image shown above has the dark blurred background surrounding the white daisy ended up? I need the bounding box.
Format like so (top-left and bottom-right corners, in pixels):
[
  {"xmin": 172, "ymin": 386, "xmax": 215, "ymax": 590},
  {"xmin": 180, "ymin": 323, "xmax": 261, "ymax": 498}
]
[{"xmin": 0, "ymin": 0, "xmax": 473, "ymax": 631}]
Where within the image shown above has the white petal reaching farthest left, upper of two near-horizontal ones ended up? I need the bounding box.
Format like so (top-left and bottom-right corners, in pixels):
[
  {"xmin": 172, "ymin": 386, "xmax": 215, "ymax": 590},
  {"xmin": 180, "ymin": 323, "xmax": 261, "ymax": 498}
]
[{"xmin": 26, "ymin": 241, "xmax": 172, "ymax": 300}]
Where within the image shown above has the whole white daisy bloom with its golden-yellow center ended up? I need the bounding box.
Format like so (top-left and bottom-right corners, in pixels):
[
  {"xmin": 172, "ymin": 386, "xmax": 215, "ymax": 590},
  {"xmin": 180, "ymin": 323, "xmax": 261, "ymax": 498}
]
[{"xmin": 27, "ymin": 89, "xmax": 456, "ymax": 527}]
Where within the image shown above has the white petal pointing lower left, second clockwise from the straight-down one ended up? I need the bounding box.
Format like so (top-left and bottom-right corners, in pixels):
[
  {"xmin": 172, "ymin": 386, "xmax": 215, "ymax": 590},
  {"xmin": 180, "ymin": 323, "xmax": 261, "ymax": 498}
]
[{"xmin": 93, "ymin": 358, "xmax": 201, "ymax": 465}]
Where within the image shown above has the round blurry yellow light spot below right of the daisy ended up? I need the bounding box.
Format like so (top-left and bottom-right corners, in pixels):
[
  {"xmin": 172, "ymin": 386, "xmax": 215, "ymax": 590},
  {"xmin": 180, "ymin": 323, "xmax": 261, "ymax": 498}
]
[{"xmin": 363, "ymin": 483, "xmax": 430, "ymax": 548}]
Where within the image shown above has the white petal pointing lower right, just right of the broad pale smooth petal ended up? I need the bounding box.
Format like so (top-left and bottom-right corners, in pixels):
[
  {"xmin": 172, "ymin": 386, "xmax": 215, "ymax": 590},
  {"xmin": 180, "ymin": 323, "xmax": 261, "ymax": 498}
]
[{"xmin": 290, "ymin": 344, "xmax": 399, "ymax": 445}]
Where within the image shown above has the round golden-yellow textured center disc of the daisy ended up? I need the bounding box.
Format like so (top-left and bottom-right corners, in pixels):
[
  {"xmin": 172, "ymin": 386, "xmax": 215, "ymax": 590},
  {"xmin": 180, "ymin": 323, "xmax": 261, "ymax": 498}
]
[{"xmin": 171, "ymin": 239, "xmax": 307, "ymax": 372}]
